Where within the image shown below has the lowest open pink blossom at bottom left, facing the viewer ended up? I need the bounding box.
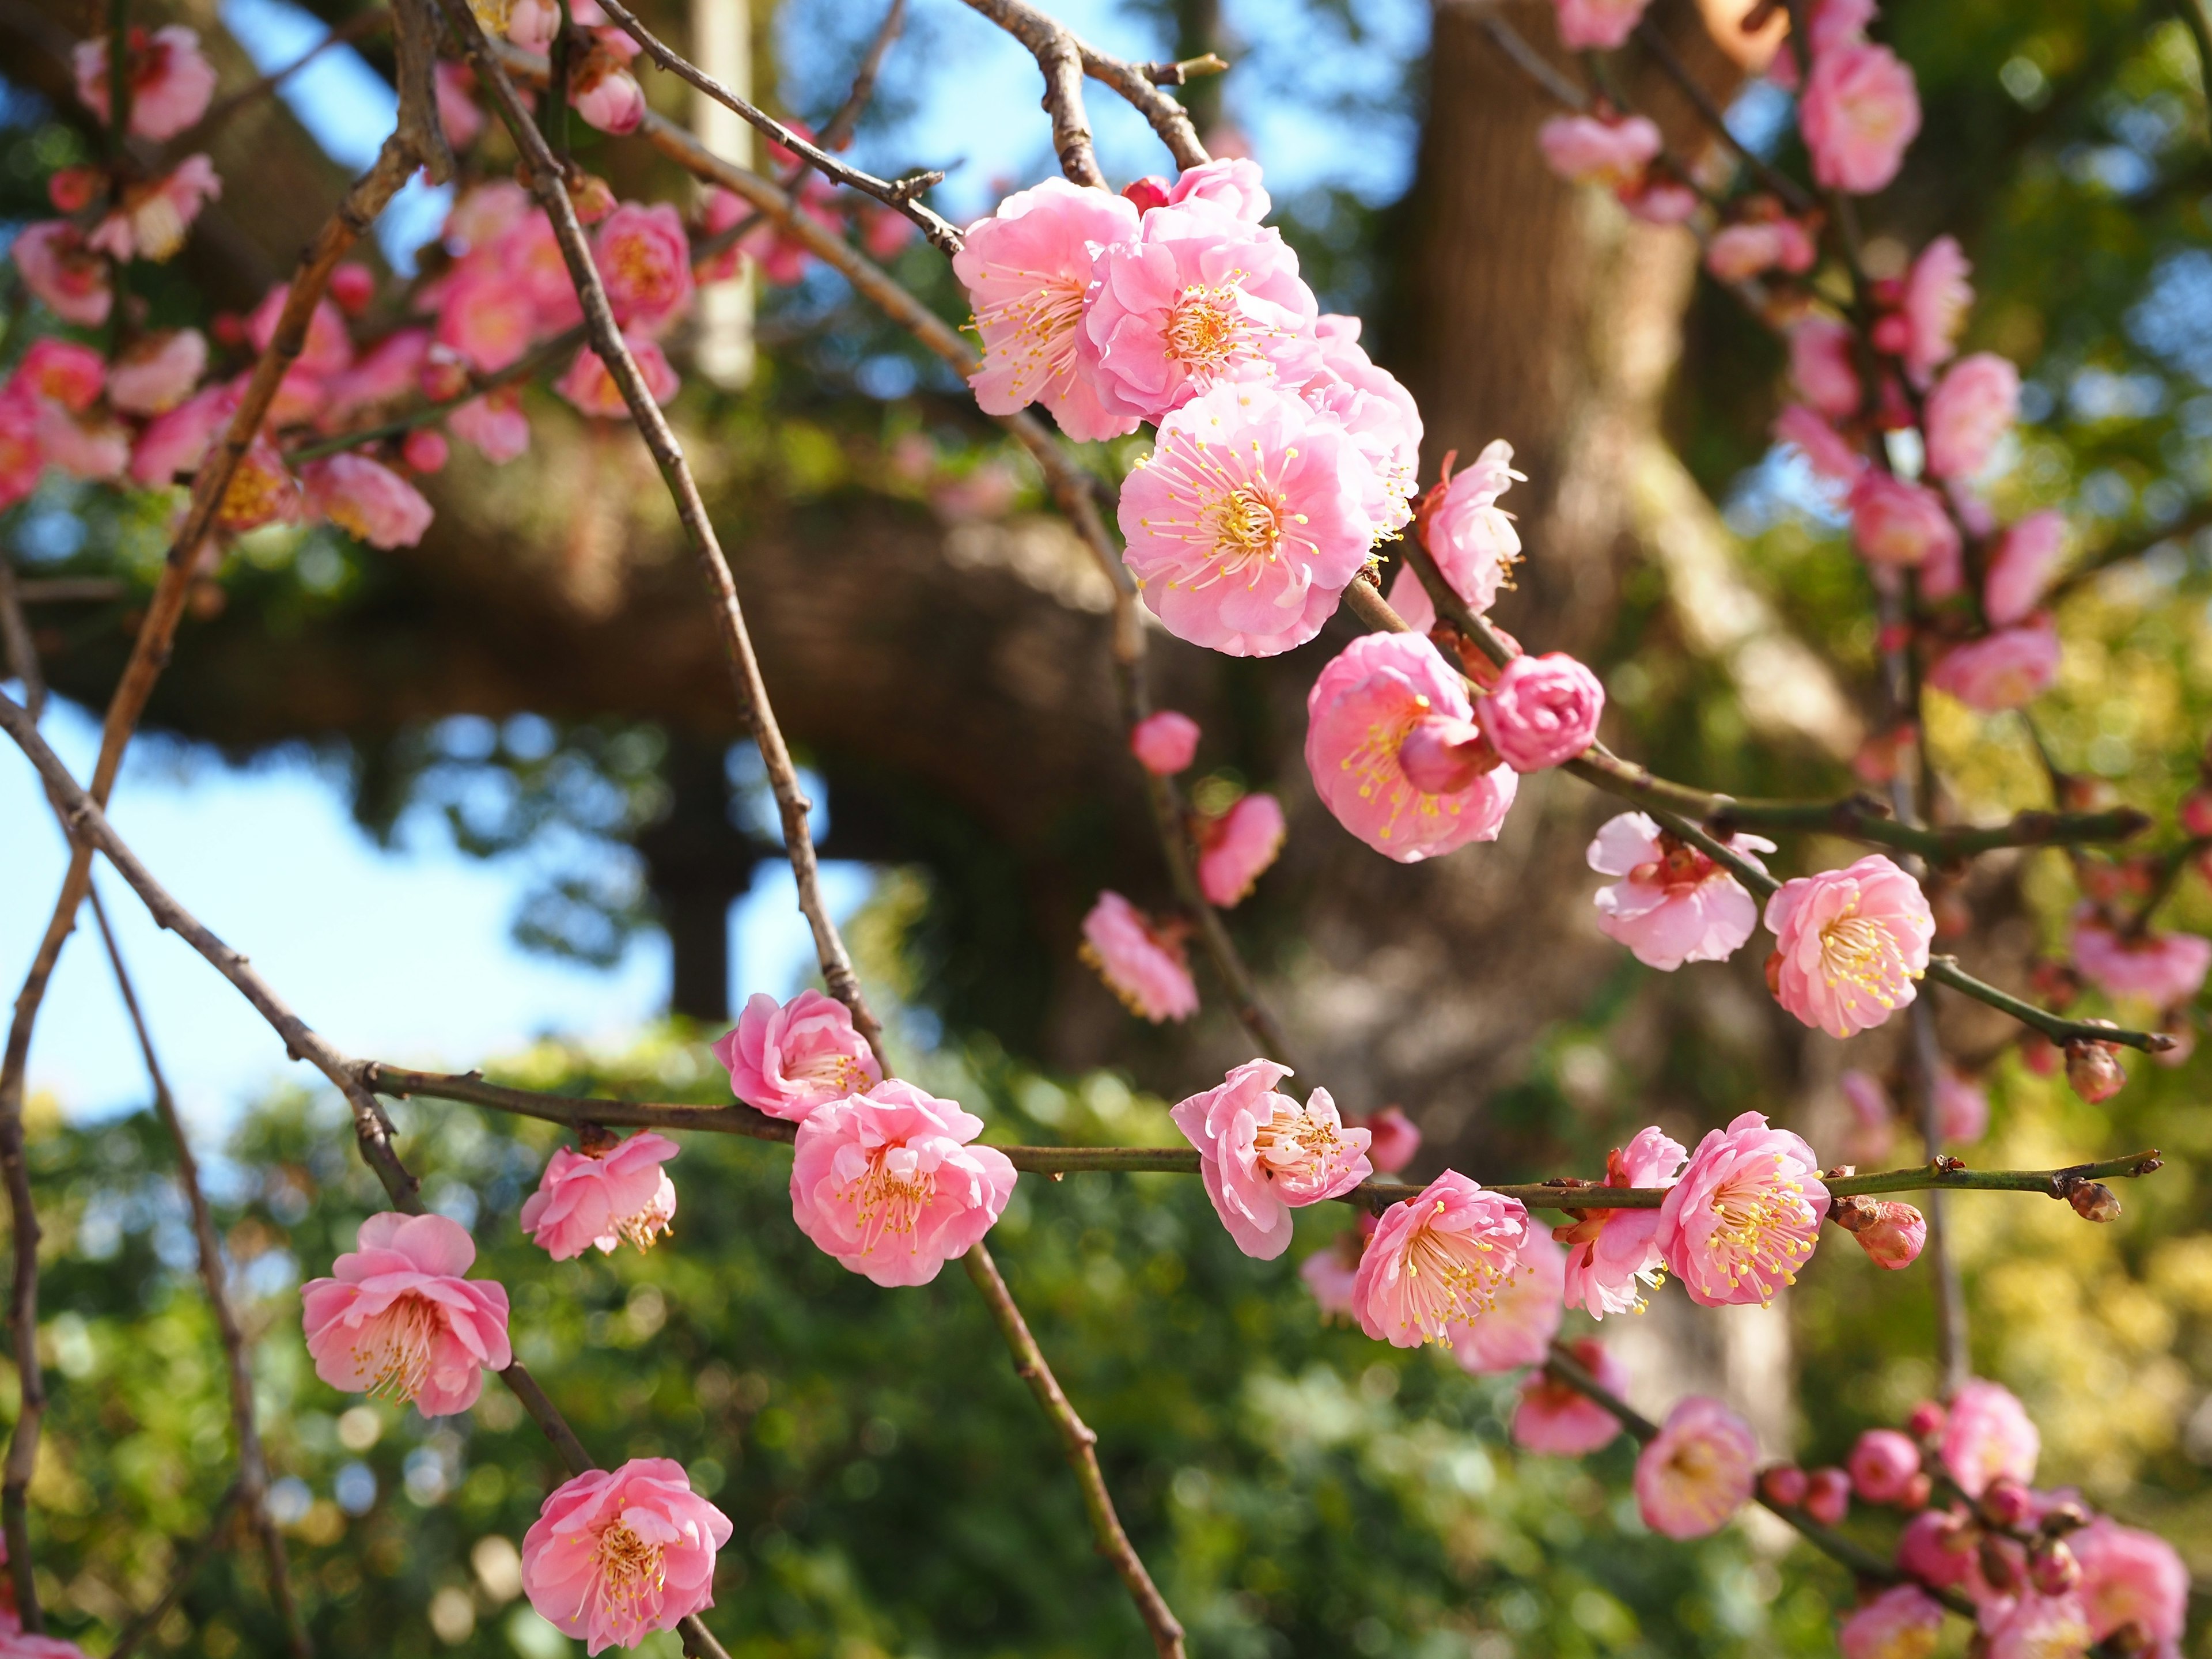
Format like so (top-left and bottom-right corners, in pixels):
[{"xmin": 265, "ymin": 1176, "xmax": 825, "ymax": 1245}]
[{"xmin": 522, "ymin": 1458, "xmax": 730, "ymax": 1652}]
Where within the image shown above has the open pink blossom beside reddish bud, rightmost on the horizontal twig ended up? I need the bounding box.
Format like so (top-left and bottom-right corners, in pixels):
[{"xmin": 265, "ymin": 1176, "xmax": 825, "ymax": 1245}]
[{"xmin": 1659, "ymin": 1113, "xmax": 1827, "ymax": 1307}]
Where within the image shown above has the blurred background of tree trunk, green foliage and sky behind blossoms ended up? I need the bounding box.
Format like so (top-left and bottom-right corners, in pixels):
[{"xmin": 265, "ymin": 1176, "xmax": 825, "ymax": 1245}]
[{"xmin": 0, "ymin": 0, "xmax": 2212, "ymax": 1659}]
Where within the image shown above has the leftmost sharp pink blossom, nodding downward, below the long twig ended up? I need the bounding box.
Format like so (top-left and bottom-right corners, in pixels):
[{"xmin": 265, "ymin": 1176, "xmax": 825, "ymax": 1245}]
[{"xmin": 301, "ymin": 1210, "xmax": 513, "ymax": 1418}]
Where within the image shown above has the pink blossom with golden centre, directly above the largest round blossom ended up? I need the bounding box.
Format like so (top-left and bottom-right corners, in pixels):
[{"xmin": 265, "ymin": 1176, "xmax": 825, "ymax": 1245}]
[{"xmin": 1077, "ymin": 197, "xmax": 1320, "ymax": 422}]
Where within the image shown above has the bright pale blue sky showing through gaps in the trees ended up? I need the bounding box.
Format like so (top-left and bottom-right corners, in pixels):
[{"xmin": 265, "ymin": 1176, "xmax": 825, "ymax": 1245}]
[{"xmin": 0, "ymin": 0, "xmax": 1425, "ymax": 1128}]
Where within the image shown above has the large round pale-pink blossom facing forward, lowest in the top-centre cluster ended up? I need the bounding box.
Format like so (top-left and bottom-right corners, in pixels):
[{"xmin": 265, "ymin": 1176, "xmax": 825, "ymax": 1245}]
[{"xmin": 1119, "ymin": 380, "xmax": 1374, "ymax": 657}]
